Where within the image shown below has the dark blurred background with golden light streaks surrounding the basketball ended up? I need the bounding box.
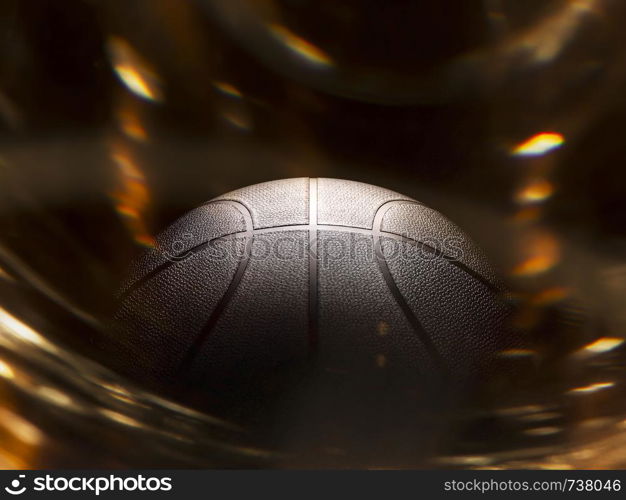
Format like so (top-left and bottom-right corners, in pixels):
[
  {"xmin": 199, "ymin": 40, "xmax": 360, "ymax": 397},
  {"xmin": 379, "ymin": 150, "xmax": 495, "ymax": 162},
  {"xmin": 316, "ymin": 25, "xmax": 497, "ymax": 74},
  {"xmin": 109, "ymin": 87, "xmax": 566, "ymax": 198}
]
[{"xmin": 0, "ymin": 0, "xmax": 626, "ymax": 468}]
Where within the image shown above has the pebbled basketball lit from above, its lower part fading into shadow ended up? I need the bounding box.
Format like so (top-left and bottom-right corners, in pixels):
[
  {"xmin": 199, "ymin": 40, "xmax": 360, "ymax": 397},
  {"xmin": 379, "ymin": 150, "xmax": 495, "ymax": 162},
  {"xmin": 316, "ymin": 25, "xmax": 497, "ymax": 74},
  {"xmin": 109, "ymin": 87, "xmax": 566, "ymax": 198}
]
[{"xmin": 113, "ymin": 178, "xmax": 516, "ymax": 420}]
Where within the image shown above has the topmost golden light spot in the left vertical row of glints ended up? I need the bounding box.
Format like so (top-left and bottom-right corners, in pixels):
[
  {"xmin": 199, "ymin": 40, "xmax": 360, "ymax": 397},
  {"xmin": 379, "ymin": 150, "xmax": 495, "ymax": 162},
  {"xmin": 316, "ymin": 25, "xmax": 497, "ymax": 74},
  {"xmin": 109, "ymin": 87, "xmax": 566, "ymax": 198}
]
[{"xmin": 107, "ymin": 36, "xmax": 163, "ymax": 102}]
